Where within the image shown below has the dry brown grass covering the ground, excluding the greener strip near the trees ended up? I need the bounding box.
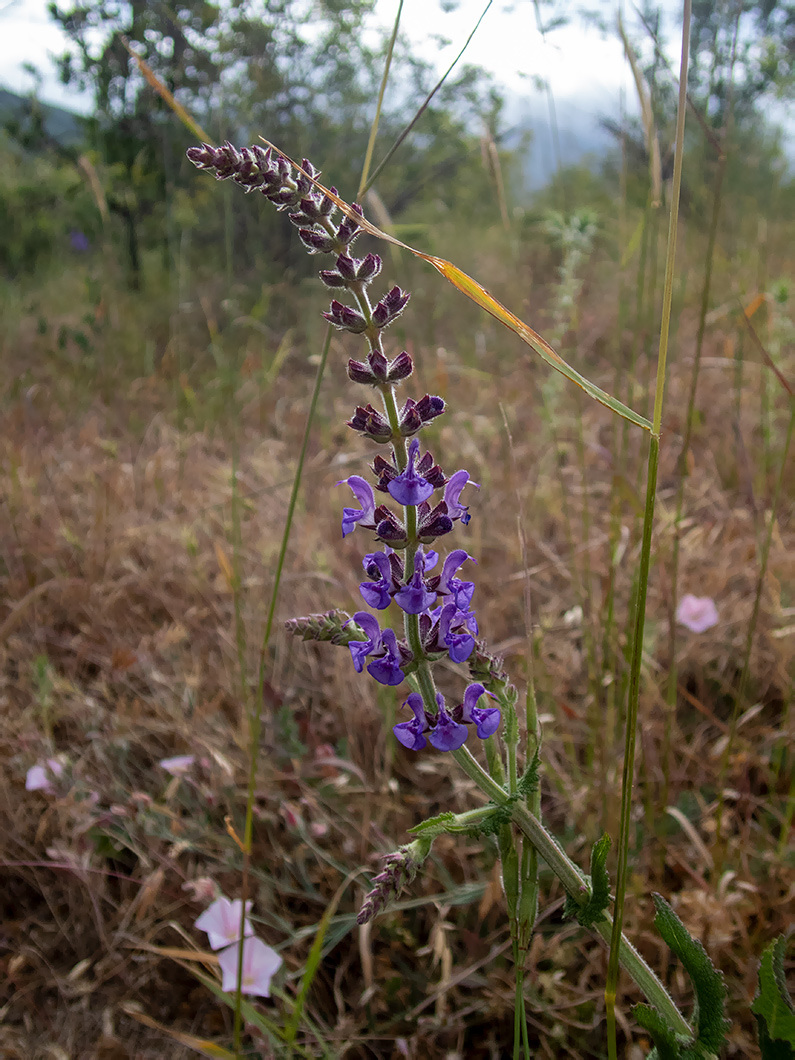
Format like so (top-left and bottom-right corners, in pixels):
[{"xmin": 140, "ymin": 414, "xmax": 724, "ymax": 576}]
[{"xmin": 0, "ymin": 242, "xmax": 795, "ymax": 1060}]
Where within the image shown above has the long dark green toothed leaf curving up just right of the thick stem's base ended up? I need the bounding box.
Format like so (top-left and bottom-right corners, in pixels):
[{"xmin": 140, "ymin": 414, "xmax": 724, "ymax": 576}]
[{"xmin": 652, "ymin": 895, "xmax": 729, "ymax": 1058}]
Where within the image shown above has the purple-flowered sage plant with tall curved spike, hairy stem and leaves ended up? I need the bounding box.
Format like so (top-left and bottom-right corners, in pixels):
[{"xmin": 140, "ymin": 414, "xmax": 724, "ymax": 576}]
[{"xmin": 188, "ymin": 143, "xmax": 725, "ymax": 1058}]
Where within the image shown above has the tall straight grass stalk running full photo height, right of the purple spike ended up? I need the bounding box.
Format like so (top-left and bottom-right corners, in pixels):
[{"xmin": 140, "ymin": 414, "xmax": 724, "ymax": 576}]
[{"xmin": 604, "ymin": 6, "xmax": 691, "ymax": 1060}]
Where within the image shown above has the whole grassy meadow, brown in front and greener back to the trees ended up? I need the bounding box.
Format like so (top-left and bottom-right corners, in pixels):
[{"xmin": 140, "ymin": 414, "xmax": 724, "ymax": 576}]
[{"xmin": 0, "ymin": 6, "xmax": 795, "ymax": 1060}]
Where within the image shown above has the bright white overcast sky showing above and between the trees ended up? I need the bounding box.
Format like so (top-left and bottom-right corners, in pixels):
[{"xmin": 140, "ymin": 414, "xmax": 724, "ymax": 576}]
[{"xmin": 0, "ymin": 0, "xmax": 661, "ymax": 118}]
